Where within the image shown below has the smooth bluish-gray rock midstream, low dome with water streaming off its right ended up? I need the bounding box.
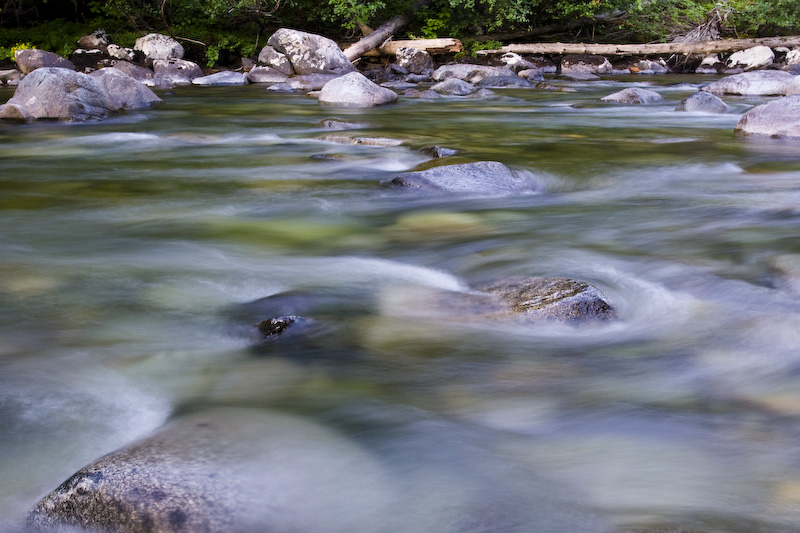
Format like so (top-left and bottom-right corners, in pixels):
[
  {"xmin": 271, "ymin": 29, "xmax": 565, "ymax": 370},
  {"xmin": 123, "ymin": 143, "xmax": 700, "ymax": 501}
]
[{"xmin": 391, "ymin": 161, "xmax": 539, "ymax": 194}]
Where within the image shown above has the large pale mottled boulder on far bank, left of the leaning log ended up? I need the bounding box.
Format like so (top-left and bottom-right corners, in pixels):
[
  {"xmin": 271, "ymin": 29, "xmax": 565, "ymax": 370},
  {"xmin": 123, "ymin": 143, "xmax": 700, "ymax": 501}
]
[{"xmin": 267, "ymin": 28, "xmax": 355, "ymax": 74}]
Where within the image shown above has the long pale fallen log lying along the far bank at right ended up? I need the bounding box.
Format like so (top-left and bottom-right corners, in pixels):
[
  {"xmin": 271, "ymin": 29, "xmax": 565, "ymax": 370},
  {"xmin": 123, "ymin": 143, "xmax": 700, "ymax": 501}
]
[{"xmin": 477, "ymin": 35, "xmax": 800, "ymax": 56}]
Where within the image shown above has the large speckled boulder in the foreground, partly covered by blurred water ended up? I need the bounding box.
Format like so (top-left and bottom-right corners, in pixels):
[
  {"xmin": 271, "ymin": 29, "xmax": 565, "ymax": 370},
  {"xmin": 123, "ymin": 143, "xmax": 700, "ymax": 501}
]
[{"xmin": 28, "ymin": 409, "xmax": 392, "ymax": 533}]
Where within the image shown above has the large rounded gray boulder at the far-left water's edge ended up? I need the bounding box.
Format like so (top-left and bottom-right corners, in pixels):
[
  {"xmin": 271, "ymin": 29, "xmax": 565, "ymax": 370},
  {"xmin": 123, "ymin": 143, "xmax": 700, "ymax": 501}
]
[{"xmin": 1, "ymin": 67, "xmax": 121, "ymax": 121}]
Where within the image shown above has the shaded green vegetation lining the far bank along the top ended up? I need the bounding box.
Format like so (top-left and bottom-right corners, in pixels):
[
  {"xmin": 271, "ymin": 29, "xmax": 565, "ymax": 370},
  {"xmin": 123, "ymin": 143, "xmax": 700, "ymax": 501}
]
[{"xmin": 0, "ymin": 0, "xmax": 800, "ymax": 64}]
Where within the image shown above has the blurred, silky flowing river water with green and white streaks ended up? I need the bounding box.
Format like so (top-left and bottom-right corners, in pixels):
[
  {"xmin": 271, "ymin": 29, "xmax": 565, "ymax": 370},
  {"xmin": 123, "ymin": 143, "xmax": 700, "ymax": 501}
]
[{"xmin": 0, "ymin": 76, "xmax": 800, "ymax": 533}]
